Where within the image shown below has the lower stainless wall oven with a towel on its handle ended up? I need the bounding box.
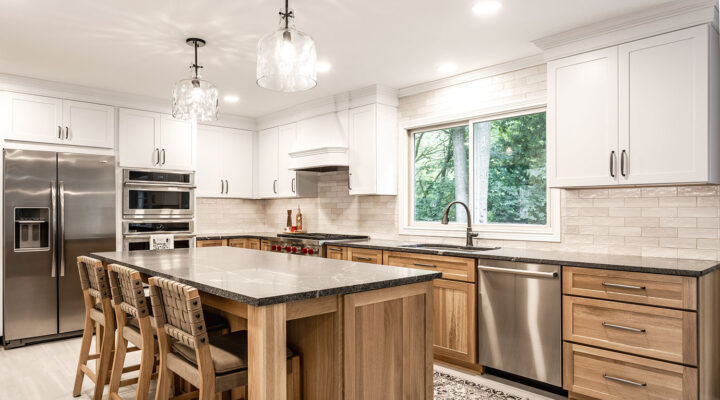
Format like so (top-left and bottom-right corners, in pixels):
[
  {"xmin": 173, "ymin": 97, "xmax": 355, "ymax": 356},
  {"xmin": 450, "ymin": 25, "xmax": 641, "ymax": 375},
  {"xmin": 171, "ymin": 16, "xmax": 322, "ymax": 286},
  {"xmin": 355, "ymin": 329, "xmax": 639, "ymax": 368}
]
[{"xmin": 123, "ymin": 219, "xmax": 195, "ymax": 251}]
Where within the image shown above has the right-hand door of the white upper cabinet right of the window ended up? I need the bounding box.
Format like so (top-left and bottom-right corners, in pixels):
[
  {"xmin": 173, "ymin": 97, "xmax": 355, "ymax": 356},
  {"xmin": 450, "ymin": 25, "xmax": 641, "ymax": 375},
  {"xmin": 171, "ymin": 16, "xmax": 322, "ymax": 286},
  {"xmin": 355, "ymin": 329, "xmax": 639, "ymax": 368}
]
[{"xmin": 619, "ymin": 26, "xmax": 720, "ymax": 184}]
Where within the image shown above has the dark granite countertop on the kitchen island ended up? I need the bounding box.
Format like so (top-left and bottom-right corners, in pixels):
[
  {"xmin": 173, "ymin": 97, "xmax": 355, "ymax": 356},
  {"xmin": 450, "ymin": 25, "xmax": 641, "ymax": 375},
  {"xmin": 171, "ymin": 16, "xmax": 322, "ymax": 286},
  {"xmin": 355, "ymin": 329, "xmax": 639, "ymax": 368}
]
[{"xmin": 92, "ymin": 247, "xmax": 441, "ymax": 306}]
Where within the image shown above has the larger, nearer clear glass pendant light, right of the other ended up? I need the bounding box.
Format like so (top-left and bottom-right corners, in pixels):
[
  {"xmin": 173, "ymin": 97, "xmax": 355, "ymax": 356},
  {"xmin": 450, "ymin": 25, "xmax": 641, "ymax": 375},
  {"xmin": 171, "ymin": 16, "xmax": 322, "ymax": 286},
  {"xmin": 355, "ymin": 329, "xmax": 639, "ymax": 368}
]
[{"xmin": 257, "ymin": 0, "xmax": 317, "ymax": 92}]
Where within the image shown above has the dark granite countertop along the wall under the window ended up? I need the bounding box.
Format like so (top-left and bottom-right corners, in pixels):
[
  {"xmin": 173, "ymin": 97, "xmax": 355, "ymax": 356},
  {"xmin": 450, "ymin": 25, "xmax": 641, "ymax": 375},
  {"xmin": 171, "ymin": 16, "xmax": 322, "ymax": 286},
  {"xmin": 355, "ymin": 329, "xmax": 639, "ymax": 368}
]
[{"xmin": 338, "ymin": 239, "xmax": 720, "ymax": 276}]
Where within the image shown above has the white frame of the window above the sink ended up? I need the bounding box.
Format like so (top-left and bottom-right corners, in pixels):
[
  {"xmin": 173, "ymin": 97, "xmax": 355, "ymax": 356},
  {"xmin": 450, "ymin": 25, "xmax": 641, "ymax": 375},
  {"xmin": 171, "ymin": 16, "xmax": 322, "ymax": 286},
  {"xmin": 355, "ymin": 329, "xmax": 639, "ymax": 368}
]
[{"xmin": 398, "ymin": 100, "xmax": 560, "ymax": 242}]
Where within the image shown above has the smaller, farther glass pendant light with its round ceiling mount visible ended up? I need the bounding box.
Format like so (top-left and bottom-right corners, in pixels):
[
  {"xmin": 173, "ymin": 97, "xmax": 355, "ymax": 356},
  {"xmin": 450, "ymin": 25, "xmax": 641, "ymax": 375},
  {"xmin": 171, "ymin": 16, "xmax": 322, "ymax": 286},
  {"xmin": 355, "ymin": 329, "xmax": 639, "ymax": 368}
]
[{"xmin": 172, "ymin": 38, "xmax": 219, "ymax": 121}]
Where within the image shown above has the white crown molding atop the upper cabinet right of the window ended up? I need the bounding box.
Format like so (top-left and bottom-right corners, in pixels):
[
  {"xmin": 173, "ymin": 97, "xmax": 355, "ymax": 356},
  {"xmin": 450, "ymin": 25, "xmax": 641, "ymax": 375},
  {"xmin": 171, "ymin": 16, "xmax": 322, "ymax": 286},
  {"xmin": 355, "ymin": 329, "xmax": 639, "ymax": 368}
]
[{"xmin": 533, "ymin": 0, "xmax": 718, "ymax": 61}]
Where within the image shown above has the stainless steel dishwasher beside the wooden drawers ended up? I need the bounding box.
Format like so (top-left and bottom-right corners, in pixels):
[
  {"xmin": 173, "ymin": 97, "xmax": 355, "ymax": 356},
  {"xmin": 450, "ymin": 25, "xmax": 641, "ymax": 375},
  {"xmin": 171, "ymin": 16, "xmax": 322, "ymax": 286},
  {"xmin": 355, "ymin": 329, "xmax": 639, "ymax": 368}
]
[{"xmin": 477, "ymin": 259, "xmax": 562, "ymax": 386}]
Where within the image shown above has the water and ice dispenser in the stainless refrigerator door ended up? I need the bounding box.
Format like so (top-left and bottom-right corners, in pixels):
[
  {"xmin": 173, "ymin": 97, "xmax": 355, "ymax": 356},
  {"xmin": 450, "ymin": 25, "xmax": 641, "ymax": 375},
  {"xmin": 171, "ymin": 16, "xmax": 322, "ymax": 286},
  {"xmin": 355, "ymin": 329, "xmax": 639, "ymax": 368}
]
[{"xmin": 15, "ymin": 207, "xmax": 50, "ymax": 251}]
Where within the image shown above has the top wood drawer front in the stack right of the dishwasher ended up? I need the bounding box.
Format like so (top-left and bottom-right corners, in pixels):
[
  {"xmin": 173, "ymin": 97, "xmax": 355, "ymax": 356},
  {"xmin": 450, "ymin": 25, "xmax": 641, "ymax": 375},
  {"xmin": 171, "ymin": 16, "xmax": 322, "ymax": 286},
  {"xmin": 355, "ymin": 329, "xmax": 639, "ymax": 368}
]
[{"xmin": 563, "ymin": 267, "xmax": 697, "ymax": 310}]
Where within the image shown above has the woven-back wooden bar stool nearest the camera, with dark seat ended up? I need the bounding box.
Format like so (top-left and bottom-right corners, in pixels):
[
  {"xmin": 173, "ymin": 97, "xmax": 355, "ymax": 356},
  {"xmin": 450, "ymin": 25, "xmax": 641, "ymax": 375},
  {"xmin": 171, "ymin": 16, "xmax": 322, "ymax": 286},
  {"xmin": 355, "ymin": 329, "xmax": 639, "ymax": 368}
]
[{"xmin": 149, "ymin": 277, "xmax": 300, "ymax": 400}]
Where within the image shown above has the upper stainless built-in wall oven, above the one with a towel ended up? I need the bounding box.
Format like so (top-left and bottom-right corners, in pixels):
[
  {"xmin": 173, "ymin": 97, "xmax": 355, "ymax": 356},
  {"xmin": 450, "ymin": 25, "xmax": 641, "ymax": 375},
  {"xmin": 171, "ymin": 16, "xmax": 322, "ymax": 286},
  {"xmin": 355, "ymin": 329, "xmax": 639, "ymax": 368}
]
[{"xmin": 123, "ymin": 169, "xmax": 195, "ymax": 219}]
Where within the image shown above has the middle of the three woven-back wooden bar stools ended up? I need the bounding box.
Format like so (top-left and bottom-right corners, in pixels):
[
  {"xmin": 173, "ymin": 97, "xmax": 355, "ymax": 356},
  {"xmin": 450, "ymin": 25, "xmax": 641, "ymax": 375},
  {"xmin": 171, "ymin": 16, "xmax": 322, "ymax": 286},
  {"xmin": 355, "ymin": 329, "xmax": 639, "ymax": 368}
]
[{"xmin": 107, "ymin": 264, "xmax": 157, "ymax": 400}]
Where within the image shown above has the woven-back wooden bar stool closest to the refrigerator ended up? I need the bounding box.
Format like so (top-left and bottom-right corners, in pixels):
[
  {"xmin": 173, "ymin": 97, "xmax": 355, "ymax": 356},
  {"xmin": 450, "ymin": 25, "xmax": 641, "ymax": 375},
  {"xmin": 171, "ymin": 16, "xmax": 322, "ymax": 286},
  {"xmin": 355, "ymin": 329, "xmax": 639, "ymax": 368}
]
[{"xmin": 73, "ymin": 256, "xmax": 115, "ymax": 400}]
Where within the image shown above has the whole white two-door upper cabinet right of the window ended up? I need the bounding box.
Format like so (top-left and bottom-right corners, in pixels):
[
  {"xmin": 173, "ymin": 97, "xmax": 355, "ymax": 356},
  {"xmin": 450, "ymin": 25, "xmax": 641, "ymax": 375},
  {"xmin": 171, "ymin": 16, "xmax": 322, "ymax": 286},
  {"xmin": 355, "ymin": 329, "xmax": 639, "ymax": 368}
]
[{"xmin": 547, "ymin": 25, "xmax": 720, "ymax": 187}]
